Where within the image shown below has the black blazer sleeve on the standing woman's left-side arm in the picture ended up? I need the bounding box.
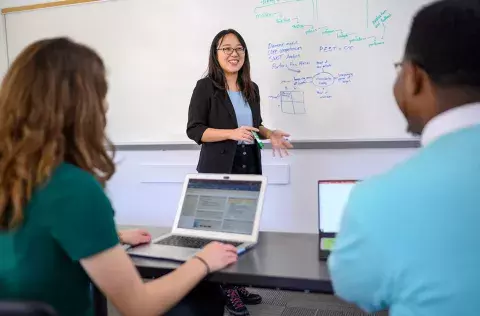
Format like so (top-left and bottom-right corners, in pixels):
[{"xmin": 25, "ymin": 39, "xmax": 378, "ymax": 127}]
[{"xmin": 187, "ymin": 80, "xmax": 210, "ymax": 145}]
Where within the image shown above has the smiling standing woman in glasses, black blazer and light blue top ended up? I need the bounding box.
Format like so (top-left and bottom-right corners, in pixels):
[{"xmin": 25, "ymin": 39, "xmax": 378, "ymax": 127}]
[{"xmin": 187, "ymin": 29, "xmax": 292, "ymax": 315}]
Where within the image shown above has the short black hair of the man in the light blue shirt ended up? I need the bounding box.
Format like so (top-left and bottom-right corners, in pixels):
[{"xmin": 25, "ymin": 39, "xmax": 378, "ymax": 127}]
[{"xmin": 405, "ymin": 0, "xmax": 480, "ymax": 87}]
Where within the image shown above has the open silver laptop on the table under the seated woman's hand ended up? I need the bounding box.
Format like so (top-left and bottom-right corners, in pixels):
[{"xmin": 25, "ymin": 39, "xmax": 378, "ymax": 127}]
[{"xmin": 128, "ymin": 174, "xmax": 267, "ymax": 262}]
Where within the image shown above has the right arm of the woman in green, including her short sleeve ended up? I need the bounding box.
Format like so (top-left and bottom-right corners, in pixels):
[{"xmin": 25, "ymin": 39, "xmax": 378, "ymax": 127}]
[{"xmin": 49, "ymin": 174, "xmax": 237, "ymax": 316}]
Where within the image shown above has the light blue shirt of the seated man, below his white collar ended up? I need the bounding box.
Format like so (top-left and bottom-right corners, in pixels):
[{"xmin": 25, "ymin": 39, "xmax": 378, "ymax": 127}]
[{"xmin": 328, "ymin": 125, "xmax": 480, "ymax": 316}]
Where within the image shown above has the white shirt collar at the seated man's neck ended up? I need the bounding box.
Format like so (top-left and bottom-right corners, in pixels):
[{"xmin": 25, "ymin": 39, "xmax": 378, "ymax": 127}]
[{"xmin": 422, "ymin": 103, "xmax": 480, "ymax": 146}]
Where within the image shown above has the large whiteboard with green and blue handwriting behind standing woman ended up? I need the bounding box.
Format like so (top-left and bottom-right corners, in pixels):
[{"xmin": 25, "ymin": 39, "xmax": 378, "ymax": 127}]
[{"xmin": 1, "ymin": 0, "xmax": 428, "ymax": 145}]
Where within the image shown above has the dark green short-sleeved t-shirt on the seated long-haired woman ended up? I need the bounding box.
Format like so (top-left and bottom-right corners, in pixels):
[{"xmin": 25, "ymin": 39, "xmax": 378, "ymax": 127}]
[{"xmin": 0, "ymin": 163, "xmax": 119, "ymax": 316}]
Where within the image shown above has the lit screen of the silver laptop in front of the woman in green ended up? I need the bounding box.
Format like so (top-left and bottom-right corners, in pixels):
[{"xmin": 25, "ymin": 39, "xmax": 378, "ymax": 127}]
[{"xmin": 178, "ymin": 179, "xmax": 262, "ymax": 235}]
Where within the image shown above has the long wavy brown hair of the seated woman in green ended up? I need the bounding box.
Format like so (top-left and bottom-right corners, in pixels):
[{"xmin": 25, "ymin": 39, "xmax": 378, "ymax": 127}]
[{"xmin": 0, "ymin": 38, "xmax": 115, "ymax": 230}]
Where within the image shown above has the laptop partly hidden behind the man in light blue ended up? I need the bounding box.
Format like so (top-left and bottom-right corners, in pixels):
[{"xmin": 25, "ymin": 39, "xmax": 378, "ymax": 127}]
[{"xmin": 318, "ymin": 180, "xmax": 358, "ymax": 260}]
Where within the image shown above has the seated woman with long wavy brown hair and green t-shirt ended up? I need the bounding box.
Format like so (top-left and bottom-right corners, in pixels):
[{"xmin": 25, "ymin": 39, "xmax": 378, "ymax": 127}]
[{"xmin": 0, "ymin": 38, "xmax": 237, "ymax": 316}]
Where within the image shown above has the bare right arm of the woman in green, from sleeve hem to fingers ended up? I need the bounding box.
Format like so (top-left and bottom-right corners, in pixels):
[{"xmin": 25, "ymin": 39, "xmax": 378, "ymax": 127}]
[{"xmin": 84, "ymin": 243, "xmax": 237, "ymax": 316}]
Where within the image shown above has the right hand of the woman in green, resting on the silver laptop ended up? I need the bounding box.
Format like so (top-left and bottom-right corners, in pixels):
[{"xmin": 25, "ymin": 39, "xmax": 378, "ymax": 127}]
[{"xmin": 197, "ymin": 241, "xmax": 238, "ymax": 272}]
